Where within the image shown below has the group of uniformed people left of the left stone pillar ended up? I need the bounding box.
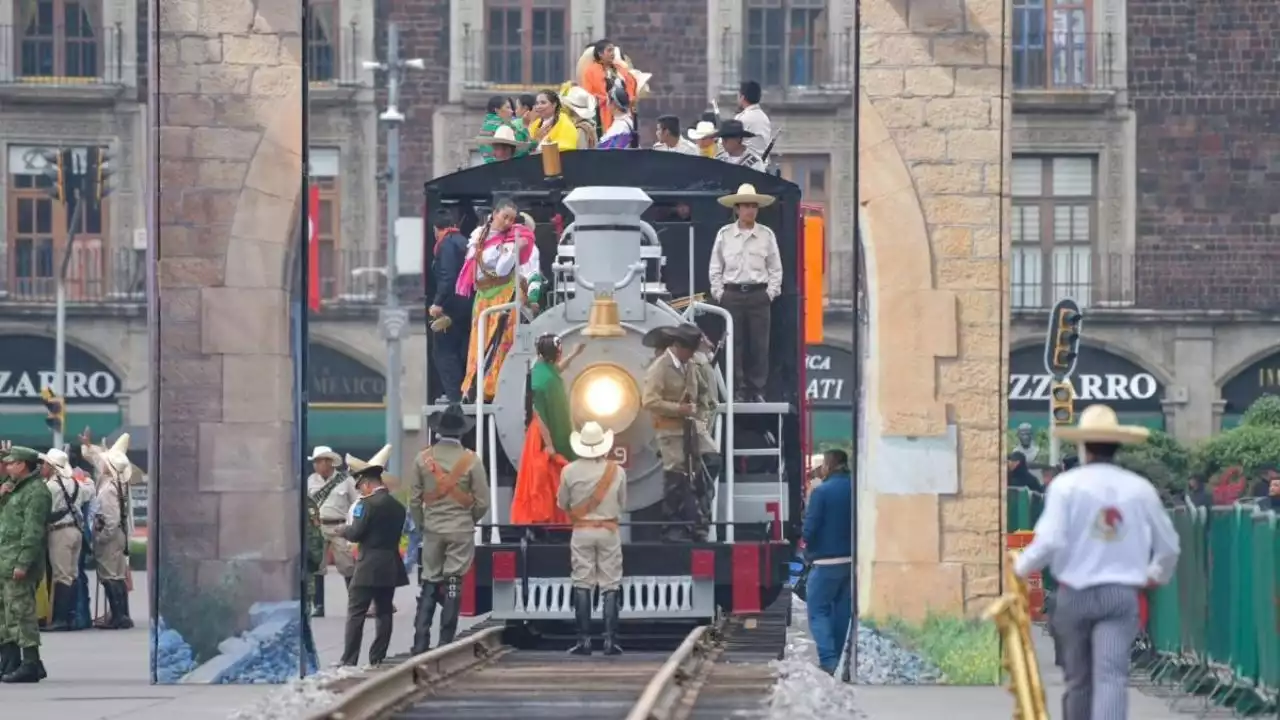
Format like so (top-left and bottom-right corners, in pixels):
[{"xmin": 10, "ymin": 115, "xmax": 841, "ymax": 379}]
[{"xmin": 0, "ymin": 430, "xmax": 141, "ymax": 683}]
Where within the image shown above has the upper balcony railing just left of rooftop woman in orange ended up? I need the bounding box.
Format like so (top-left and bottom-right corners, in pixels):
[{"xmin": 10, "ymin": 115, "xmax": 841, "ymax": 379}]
[{"xmin": 461, "ymin": 24, "xmax": 596, "ymax": 91}]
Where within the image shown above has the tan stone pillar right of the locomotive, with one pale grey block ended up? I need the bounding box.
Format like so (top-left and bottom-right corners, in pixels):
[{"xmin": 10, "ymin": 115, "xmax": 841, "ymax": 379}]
[{"xmin": 859, "ymin": 0, "xmax": 1010, "ymax": 619}]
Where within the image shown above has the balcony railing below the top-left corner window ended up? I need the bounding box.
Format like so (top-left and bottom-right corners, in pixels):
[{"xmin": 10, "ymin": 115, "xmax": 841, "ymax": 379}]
[{"xmin": 0, "ymin": 23, "xmax": 124, "ymax": 87}]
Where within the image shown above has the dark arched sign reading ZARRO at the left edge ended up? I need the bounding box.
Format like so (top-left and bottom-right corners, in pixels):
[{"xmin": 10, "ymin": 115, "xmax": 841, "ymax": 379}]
[{"xmin": 0, "ymin": 334, "xmax": 120, "ymax": 405}]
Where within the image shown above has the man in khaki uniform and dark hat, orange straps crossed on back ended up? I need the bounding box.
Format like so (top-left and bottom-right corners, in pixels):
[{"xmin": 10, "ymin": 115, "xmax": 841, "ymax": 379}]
[{"xmin": 411, "ymin": 405, "xmax": 489, "ymax": 653}]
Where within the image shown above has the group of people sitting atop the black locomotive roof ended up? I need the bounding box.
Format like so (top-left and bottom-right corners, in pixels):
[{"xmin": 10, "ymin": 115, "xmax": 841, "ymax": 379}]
[{"xmin": 476, "ymin": 40, "xmax": 773, "ymax": 170}]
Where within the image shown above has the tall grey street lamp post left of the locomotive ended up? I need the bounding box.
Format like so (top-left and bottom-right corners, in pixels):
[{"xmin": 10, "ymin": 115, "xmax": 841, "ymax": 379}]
[{"xmin": 364, "ymin": 23, "xmax": 426, "ymax": 475}]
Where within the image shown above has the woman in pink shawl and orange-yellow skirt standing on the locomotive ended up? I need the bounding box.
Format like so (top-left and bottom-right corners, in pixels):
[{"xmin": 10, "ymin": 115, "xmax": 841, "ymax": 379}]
[{"xmin": 454, "ymin": 199, "xmax": 534, "ymax": 400}]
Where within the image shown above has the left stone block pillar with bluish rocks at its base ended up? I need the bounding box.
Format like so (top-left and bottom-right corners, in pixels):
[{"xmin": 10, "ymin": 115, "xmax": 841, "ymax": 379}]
[{"xmin": 150, "ymin": 0, "xmax": 303, "ymax": 683}]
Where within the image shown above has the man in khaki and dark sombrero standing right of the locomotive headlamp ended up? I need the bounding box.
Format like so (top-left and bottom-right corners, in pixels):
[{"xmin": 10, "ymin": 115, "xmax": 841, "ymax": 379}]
[{"xmin": 641, "ymin": 325, "xmax": 699, "ymax": 542}]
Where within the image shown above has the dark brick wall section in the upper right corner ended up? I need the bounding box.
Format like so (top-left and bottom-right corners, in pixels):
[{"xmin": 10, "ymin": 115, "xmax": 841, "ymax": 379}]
[{"xmin": 1128, "ymin": 0, "xmax": 1280, "ymax": 310}]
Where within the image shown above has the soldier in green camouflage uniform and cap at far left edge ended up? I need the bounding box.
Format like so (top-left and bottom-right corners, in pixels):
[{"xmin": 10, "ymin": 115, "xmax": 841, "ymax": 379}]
[{"xmin": 0, "ymin": 446, "xmax": 54, "ymax": 683}]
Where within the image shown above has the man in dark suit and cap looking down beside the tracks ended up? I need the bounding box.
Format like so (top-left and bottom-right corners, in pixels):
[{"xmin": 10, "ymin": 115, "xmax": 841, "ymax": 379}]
[{"xmin": 339, "ymin": 445, "xmax": 408, "ymax": 666}]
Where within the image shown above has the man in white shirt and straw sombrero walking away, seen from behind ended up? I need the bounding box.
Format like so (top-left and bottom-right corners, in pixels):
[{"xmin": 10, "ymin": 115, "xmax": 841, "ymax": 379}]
[{"xmin": 1014, "ymin": 405, "xmax": 1179, "ymax": 720}]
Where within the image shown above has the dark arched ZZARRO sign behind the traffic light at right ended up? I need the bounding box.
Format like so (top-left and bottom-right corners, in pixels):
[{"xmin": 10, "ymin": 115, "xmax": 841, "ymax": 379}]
[{"xmin": 1009, "ymin": 343, "xmax": 1165, "ymax": 413}]
